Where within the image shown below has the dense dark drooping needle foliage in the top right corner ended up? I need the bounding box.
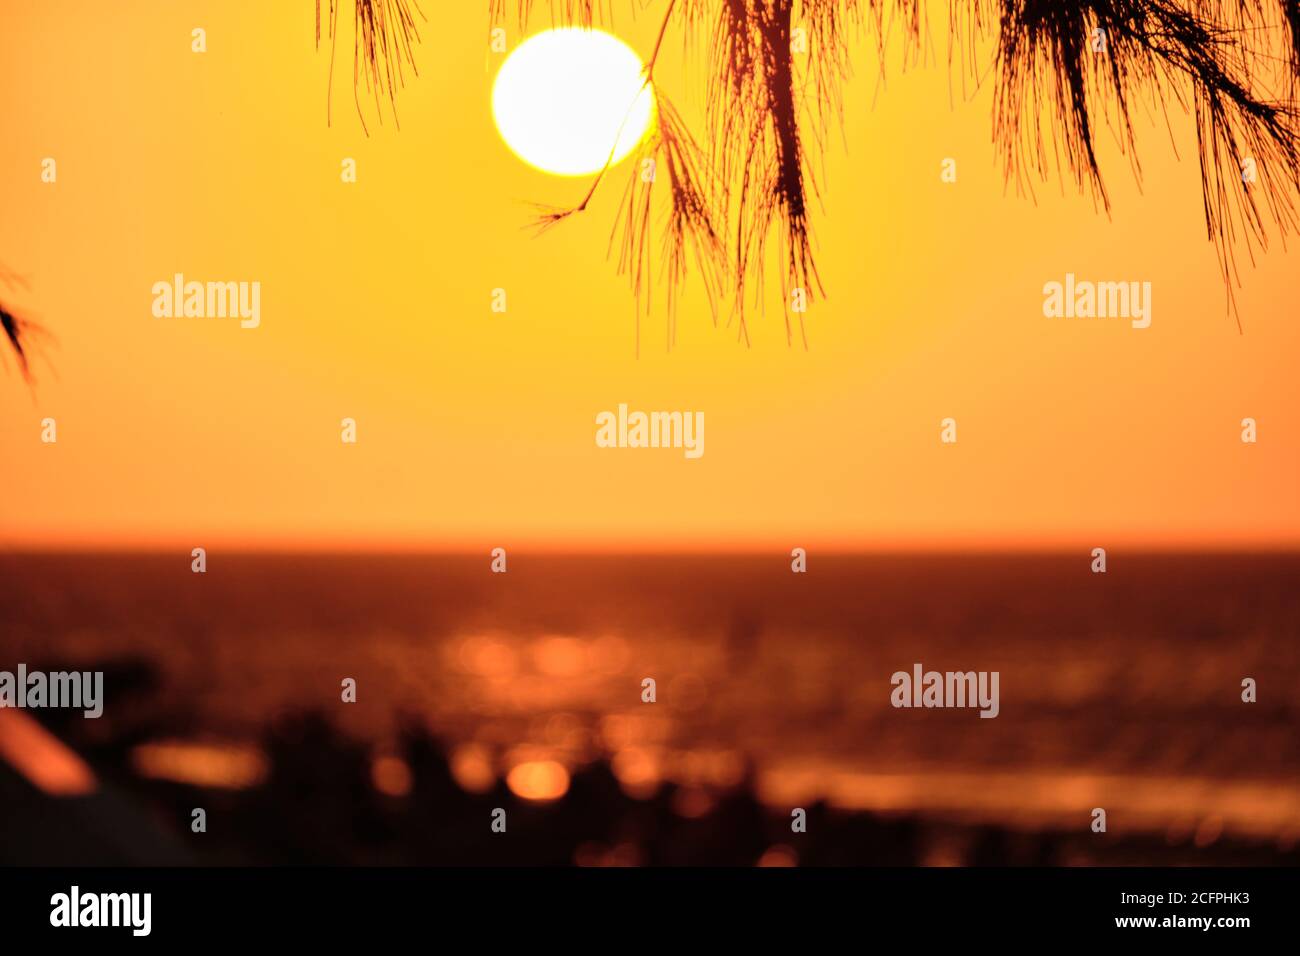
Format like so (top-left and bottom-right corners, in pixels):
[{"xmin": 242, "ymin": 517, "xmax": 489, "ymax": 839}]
[{"xmin": 974, "ymin": 0, "xmax": 1300, "ymax": 321}]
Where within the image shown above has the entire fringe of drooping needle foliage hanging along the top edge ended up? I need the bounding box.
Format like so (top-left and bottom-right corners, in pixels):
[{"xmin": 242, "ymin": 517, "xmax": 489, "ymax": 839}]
[{"xmin": 317, "ymin": 0, "xmax": 1300, "ymax": 342}]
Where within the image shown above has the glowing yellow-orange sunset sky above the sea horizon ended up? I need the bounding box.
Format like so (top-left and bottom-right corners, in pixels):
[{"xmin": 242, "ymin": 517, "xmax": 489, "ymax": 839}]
[{"xmin": 0, "ymin": 0, "xmax": 1300, "ymax": 550}]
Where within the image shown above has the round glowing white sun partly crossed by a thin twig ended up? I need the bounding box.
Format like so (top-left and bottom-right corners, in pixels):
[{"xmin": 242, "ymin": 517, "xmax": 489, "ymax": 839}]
[{"xmin": 491, "ymin": 27, "xmax": 654, "ymax": 176}]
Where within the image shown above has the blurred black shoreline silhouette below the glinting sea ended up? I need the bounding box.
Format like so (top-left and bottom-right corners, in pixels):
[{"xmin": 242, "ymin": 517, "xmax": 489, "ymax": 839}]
[{"xmin": 0, "ymin": 697, "xmax": 1300, "ymax": 866}]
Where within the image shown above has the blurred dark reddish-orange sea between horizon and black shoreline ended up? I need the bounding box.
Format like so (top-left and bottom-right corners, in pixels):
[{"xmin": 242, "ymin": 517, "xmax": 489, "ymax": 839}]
[{"xmin": 0, "ymin": 551, "xmax": 1300, "ymax": 849}]
